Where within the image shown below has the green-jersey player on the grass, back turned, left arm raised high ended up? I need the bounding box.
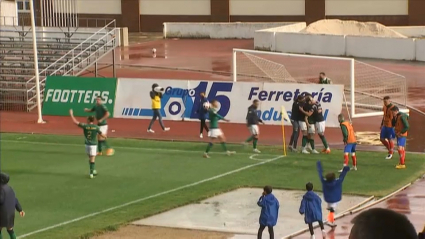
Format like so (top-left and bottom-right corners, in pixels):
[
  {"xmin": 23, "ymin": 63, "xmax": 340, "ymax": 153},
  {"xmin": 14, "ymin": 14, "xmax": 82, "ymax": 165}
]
[{"xmin": 69, "ymin": 109, "xmax": 106, "ymax": 178}]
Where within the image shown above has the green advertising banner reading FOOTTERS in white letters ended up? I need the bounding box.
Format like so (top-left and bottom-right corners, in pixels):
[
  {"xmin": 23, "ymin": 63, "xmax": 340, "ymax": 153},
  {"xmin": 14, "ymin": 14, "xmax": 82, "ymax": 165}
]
[{"xmin": 42, "ymin": 76, "xmax": 117, "ymax": 117}]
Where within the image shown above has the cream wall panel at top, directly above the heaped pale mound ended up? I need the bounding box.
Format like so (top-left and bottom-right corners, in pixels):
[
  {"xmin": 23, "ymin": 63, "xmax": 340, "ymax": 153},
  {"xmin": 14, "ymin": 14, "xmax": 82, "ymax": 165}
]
[{"xmin": 325, "ymin": 0, "xmax": 408, "ymax": 16}]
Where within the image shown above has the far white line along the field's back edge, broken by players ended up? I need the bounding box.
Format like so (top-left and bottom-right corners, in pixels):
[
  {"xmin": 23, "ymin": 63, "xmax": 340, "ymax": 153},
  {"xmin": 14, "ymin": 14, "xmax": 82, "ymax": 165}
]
[{"xmin": 0, "ymin": 140, "xmax": 282, "ymax": 156}]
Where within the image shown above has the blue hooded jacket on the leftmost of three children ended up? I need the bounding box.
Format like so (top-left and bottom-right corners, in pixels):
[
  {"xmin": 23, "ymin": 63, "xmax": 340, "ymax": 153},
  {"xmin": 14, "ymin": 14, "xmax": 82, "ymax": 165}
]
[{"xmin": 257, "ymin": 193, "xmax": 279, "ymax": 227}]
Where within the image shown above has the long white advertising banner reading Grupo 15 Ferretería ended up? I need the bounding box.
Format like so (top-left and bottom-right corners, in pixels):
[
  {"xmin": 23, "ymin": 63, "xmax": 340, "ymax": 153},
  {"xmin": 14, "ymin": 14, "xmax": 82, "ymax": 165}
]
[{"xmin": 114, "ymin": 78, "xmax": 343, "ymax": 127}]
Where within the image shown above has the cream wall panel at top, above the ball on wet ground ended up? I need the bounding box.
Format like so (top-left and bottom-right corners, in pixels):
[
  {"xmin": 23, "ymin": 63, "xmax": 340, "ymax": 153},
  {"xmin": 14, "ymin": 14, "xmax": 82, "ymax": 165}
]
[{"xmin": 139, "ymin": 0, "xmax": 211, "ymax": 15}]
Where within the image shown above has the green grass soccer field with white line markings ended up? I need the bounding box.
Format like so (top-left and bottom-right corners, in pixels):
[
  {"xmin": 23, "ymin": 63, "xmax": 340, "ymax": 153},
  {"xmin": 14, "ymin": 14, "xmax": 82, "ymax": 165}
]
[{"xmin": 1, "ymin": 134, "xmax": 425, "ymax": 239}]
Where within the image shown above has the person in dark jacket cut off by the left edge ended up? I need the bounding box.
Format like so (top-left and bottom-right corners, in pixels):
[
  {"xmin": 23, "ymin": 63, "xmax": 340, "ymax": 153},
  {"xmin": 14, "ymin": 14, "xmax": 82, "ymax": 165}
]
[{"xmin": 0, "ymin": 173, "xmax": 25, "ymax": 239}]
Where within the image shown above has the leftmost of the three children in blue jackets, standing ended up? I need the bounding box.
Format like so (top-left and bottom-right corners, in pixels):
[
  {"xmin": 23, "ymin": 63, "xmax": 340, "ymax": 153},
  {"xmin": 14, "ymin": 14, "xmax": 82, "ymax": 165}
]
[{"xmin": 257, "ymin": 186, "xmax": 279, "ymax": 239}]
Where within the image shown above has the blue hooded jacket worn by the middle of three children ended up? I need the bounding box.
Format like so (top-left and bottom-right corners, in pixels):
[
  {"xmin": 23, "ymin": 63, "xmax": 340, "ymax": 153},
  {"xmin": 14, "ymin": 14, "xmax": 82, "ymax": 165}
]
[{"xmin": 300, "ymin": 191, "xmax": 323, "ymax": 224}]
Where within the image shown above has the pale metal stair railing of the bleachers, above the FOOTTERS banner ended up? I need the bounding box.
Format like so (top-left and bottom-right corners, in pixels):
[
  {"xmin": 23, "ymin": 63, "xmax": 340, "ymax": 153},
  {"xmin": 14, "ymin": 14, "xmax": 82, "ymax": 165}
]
[{"xmin": 26, "ymin": 20, "xmax": 118, "ymax": 111}]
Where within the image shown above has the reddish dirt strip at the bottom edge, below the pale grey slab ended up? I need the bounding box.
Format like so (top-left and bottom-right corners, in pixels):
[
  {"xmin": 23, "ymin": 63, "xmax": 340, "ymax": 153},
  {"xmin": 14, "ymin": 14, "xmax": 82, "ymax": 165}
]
[{"xmin": 94, "ymin": 225, "xmax": 233, "ymax": 239}]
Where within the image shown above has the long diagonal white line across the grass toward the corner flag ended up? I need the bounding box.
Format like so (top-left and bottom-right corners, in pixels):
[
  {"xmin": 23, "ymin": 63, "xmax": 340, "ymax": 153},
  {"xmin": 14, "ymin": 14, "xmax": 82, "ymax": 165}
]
[{"xmin": 19, "ymin": 156, "xmax": 283, "ymax": 238}]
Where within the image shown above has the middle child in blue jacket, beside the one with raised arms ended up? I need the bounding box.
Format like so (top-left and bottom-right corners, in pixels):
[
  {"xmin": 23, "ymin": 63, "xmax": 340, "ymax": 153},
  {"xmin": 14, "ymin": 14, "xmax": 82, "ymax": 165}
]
[{"xmin": 300, "ymin": 183, "xmax": 326, "ymax": 239}]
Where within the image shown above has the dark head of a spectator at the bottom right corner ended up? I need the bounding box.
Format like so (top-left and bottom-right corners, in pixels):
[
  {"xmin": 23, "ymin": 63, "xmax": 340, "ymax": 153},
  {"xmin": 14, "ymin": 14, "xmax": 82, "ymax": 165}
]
[{"xmin": 349, "ymin": 208, "xmax": 418, "ymax": 239}]
